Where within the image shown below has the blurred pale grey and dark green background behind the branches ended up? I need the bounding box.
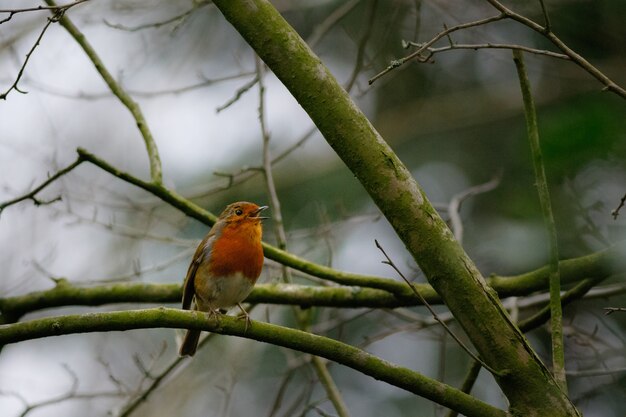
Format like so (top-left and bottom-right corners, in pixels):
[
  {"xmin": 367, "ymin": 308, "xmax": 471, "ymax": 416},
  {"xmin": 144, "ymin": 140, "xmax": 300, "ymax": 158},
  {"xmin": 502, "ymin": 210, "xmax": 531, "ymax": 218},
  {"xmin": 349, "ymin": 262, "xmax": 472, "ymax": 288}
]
[{"xmin": 0, "ymin": 0, "xmax": 626, "ymax": 417}]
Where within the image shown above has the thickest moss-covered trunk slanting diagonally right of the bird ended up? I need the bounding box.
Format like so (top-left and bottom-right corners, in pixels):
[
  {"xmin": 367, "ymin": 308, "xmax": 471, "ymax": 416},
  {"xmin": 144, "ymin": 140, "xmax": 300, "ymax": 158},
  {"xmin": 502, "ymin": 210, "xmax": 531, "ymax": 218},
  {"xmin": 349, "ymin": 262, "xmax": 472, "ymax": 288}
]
[{"xmin": 214, "ymin": 0, "xmax": 579, "ymax": 417}]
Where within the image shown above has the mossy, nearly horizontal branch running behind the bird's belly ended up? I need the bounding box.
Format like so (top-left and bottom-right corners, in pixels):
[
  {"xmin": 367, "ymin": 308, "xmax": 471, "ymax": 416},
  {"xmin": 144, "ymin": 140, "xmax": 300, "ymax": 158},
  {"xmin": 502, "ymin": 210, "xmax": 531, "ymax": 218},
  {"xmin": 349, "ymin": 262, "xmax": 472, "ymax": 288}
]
[{"xmin": 0, "ymin": 243, "xmax": 626, "ymax": 325}]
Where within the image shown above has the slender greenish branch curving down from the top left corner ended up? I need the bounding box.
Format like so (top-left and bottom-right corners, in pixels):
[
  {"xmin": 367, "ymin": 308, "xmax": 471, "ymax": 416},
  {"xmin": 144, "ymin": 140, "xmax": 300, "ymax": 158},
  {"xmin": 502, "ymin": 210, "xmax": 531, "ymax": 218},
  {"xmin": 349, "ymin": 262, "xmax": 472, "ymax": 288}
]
[{"xmin": 45, "ymin": 0, "xmax": 163, "ymax": 184}]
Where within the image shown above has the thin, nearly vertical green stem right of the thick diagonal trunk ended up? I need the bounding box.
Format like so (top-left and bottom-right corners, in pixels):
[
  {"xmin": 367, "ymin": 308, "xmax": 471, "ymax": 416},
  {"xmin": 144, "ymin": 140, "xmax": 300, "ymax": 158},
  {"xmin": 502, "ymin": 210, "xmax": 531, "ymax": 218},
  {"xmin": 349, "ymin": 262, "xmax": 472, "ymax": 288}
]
[{"xmin": 513, "ymin": 50, "xmax": 567, "ymax": 392}]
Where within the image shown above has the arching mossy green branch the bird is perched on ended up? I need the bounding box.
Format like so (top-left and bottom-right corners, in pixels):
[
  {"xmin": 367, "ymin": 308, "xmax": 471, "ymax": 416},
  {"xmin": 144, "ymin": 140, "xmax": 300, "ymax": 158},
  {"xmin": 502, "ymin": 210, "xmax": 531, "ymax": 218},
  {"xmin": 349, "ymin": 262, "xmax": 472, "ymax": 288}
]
[{"xmin": 0, "ymin": 308, "xmax": 507, "ymax": 417}]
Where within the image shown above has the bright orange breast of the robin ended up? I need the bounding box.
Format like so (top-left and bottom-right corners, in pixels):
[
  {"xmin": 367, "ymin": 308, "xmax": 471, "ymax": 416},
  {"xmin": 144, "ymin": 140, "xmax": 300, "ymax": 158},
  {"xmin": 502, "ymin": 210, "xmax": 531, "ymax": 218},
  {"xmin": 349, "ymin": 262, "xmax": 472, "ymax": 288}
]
[{"xmin": 209, "ymin": 222, "xmax": 263, "ymax": 282}]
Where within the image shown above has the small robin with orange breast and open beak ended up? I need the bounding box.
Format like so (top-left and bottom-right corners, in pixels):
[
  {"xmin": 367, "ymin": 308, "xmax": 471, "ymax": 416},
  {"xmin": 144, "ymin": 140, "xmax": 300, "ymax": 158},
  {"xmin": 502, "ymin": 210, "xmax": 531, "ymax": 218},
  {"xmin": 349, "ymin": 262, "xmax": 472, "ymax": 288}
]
[{"xmin": 179, "ymin": 201, "xmax": 267, "ymax": 356}]
